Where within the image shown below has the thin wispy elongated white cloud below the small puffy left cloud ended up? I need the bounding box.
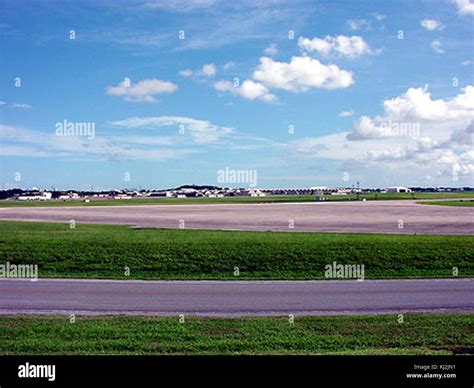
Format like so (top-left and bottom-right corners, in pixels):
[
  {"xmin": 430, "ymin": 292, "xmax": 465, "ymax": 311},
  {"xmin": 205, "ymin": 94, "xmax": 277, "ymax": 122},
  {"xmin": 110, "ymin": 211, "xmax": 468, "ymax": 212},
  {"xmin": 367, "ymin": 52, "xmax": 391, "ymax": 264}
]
[{"xmin": 109, "ymin": 116, "xmax": 233, "ymax": 144}]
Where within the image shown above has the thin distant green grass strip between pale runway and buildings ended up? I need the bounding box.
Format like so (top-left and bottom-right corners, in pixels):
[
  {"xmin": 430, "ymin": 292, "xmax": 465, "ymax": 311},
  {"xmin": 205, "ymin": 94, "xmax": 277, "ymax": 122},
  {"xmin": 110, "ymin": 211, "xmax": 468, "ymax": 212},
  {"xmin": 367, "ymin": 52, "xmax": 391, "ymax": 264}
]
[{"xmin": 0, "ymin": 191, "xmax": 474, "ymax": 207}]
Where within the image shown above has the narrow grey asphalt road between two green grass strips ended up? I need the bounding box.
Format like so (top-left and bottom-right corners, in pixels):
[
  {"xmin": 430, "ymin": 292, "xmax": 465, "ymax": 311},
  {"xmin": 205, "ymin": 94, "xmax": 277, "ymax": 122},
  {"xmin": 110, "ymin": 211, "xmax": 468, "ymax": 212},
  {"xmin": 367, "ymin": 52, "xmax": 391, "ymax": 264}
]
[{"xmin": 0, "ymin": 279, "xmax": 474, "ymax": 317}]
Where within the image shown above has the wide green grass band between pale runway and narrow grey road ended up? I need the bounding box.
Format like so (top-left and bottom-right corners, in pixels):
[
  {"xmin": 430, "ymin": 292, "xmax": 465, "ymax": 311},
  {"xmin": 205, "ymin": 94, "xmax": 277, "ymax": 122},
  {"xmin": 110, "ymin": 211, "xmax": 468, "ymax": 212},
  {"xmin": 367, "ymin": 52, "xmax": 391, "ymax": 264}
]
[{"xmin": 0, "ymin": 221, "xmax": 474, "ymax": 280}]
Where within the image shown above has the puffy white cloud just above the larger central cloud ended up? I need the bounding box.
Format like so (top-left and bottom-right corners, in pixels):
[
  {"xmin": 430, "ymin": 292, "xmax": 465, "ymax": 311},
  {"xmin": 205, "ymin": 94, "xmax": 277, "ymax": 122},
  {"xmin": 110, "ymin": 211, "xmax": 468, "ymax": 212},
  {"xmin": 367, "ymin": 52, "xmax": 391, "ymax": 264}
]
[{"xmin": 298, "ymin": 35, "xmax": 372, "ymax": 59}]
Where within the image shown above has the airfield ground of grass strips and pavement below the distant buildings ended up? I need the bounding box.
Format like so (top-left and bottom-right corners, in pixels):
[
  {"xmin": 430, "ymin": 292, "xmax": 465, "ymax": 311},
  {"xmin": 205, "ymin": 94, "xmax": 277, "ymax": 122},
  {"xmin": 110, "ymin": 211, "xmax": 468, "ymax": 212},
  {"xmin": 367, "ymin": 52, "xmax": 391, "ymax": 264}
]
[{"xmin": 0, "ymin": 200, "xmax": 474, "ymax": 355}]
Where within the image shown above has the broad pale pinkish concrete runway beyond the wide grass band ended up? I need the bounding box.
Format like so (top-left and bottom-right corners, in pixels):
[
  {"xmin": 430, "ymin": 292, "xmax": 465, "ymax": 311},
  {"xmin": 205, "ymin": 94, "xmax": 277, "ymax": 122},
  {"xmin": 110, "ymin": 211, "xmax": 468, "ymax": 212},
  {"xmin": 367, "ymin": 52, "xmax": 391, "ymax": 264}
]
[{"xmin": 0, "ymin": 200, "xmax": 474, "ymax": 235}]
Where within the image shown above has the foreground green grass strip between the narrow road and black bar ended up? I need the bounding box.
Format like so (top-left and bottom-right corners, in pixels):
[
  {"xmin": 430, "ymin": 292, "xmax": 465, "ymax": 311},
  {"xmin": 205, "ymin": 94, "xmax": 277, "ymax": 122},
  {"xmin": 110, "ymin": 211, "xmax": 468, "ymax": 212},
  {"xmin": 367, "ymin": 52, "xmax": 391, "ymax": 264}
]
[{"xmin": 0, "ymin": 314, "xmax": 474, "ymax": 355}]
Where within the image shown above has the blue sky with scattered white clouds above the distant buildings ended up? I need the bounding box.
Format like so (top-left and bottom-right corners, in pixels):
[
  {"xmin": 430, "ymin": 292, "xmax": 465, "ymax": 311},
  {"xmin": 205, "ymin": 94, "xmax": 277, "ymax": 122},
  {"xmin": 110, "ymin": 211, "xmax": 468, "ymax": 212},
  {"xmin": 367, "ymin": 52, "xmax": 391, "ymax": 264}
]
[{"xmin": 0, "ymin": 0, "xmax": 474, "ymax": 190}]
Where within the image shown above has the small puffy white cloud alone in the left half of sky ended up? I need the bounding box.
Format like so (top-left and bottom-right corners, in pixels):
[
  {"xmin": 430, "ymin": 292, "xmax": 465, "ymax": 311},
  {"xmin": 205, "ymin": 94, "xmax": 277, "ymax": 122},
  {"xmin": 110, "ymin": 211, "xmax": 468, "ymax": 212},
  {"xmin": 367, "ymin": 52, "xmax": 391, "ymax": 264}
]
[{"xmin": 106, "ymin": 78, "xmax": 178, "ymax": 103}]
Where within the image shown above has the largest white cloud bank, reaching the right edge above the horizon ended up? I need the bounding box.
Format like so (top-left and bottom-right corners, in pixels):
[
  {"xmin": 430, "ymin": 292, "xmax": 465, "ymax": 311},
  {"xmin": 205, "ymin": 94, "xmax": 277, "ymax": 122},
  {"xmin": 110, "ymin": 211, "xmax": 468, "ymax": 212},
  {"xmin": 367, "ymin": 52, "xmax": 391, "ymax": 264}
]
[{"xmin": 289, "ymin": 85, "xmax": 474, "ymax": 180}]
